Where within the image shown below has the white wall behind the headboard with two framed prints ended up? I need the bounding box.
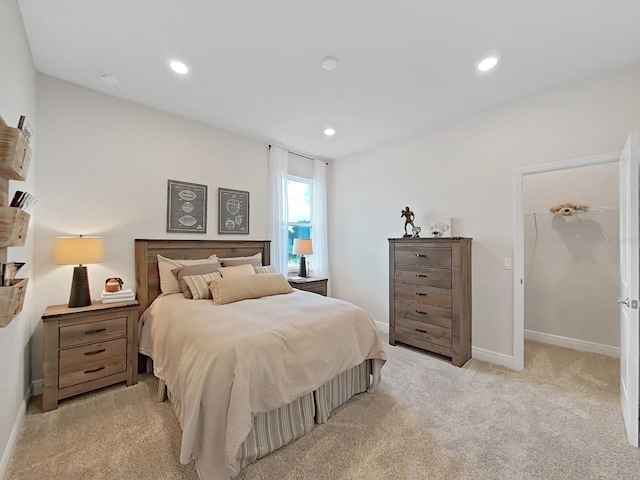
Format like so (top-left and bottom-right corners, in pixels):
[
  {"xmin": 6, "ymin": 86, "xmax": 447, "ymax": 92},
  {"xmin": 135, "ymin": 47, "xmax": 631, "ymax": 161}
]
[{"xmin": 33, "ymin": 74, "xmax": 268, "ymax": 379}]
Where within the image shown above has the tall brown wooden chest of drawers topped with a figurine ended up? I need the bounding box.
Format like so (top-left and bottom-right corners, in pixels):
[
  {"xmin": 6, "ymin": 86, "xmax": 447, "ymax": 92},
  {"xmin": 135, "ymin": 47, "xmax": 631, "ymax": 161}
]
[{"xmin": 389, "ymin": 238, "xmax": 471, "ymax": 367}]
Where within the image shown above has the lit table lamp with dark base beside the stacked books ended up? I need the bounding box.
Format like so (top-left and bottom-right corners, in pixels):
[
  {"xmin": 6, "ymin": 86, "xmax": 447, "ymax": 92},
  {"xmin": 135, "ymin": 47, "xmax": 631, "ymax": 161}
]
[{"xmin": 55, "ymin": 235, "xmax": 104, "ymax": 308}]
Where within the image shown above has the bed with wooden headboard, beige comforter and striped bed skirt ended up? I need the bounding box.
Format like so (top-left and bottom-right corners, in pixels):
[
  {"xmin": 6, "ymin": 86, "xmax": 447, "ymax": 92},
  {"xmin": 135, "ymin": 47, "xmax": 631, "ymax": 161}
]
[{"xmin": 135, "ymin": 240, "xmax": 386, "ymax": 480}]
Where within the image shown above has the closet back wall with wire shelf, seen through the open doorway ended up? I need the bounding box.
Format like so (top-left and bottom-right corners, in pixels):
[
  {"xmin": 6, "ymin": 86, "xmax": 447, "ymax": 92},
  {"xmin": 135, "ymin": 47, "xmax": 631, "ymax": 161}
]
[{"xmin": 523, "ymin": 163, "xmax": 620, "ymax": 352}]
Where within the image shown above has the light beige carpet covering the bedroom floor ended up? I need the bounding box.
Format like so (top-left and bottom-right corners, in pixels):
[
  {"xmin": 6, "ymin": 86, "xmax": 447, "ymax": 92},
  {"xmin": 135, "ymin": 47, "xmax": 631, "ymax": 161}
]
[{"xmin": 7, "ymin": 342, "xmax": 640, "ymax": 480}]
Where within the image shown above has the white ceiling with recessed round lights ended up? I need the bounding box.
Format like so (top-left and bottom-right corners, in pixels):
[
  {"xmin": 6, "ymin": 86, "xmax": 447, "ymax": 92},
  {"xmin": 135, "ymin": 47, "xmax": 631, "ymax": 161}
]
[{"xmin": 19, "ymin": 0, "xmax": 640, "ymax": 158}]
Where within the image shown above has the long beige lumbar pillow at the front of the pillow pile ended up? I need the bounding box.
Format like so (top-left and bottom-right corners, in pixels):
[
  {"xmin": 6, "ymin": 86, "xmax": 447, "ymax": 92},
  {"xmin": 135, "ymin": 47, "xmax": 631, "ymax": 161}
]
[{"xmin": 209, "ymin": 273, "xmax": 293, "ymax": 305}]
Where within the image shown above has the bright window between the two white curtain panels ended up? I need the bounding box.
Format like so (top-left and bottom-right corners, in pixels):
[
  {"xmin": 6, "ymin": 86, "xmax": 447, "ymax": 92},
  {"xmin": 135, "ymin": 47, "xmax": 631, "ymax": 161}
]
[{"xmin": 287, "ymin": 175, "xmax": 313, "ymax": 271}]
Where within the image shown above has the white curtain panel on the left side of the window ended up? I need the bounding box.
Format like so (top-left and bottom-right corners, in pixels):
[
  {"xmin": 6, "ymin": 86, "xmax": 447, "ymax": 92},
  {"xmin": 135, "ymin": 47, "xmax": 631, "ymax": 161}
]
[{"xmin": 269, "ymin": 145, "xmax": 288, "ymax": 277}]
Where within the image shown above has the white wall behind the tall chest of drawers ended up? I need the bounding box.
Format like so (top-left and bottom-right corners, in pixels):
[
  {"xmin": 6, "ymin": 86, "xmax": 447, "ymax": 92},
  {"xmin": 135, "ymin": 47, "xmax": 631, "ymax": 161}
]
[{"xmin": 329, "ymin": 66, "xmax": 640, "ymax": 364}]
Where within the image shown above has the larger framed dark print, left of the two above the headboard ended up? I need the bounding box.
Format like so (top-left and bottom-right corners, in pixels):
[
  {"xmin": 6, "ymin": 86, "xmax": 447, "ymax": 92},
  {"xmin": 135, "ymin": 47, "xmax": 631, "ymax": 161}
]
[{"xmin": 167, "ymin": 180, "xmax": 207, "ymax": 233}]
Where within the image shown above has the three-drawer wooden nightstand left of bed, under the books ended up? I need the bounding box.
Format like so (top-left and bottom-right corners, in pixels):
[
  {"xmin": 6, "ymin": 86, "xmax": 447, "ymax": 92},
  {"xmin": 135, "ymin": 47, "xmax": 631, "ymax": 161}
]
[{"xmin": 42, "ymin": 300, "xmax": 138, "ymax": 412}]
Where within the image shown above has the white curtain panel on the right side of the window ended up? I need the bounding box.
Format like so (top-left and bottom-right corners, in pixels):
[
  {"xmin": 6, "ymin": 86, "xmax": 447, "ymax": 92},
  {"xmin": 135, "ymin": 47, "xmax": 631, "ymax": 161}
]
[{"xmin": 311, "ymin": 160, "xmax": 329, "ymax": 278}]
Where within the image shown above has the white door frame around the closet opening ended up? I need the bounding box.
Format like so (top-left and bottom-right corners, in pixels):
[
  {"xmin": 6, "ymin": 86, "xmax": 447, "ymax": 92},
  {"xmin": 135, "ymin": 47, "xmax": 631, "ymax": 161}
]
[{"xmin": 512, "ymin": 152, "xmax": 620, "ymax": 370}]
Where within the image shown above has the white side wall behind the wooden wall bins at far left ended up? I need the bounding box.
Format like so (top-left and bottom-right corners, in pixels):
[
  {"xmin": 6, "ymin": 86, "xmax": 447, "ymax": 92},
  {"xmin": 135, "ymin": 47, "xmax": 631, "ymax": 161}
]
[{"xmin": 0, "ymin": 0, "xmax": 39, "ymax": 472}]
